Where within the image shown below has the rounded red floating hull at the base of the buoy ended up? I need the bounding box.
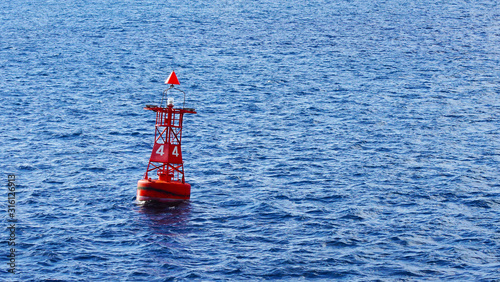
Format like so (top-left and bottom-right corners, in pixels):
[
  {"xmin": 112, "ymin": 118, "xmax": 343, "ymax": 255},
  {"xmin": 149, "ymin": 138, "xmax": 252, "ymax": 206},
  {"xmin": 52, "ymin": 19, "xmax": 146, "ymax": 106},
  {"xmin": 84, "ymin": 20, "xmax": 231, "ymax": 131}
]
[{"xmin": 137, "ymin": 179, "xmax": 191, "ymax": 202}]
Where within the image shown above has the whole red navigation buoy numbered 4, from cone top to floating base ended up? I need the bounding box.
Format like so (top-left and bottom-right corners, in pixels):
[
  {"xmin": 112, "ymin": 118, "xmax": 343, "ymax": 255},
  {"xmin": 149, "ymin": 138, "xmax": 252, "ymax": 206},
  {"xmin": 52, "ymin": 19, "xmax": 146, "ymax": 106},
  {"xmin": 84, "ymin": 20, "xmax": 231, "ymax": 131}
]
[{"xmin": 137, "ymin": 71, "xmax": 196, "ymax": 202}]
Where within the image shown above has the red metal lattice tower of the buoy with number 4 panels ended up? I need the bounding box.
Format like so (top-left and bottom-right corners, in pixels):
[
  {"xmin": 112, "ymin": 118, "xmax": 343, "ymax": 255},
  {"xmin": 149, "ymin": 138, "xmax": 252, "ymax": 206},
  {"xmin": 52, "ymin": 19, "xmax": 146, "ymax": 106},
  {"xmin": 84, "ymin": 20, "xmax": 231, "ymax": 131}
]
[{"xmin": 144, "ymin": 105, "xmax": 196, "ymax": 183}]
